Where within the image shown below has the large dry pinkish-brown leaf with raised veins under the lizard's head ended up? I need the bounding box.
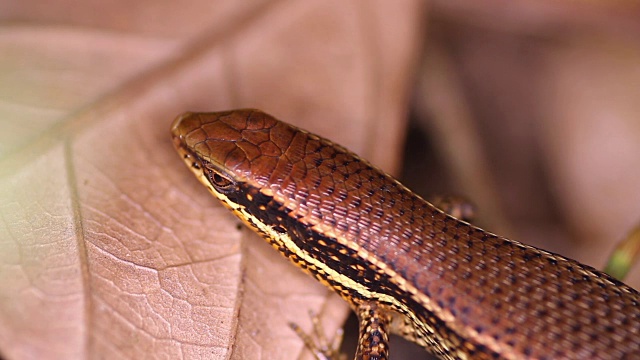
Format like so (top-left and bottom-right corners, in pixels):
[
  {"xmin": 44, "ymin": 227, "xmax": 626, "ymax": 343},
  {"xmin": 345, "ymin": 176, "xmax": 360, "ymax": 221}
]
[{"xmin": 0, "ymin": 1, "xmax": 421, "ymax": 359}]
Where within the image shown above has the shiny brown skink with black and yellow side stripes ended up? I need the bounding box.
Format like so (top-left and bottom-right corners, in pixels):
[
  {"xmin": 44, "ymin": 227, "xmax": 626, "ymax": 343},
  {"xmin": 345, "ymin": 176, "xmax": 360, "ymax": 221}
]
[{"xmin": 172, "ymin": 109, "xmax": 640, "ymax": 359}]
